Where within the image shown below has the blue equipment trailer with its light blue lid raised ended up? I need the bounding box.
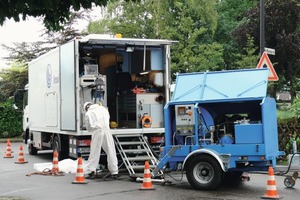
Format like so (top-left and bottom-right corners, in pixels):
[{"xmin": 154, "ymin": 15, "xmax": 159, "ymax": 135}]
[{"xmin": 153, "ymin": 69, "xmax": 284, "ymax": 189}]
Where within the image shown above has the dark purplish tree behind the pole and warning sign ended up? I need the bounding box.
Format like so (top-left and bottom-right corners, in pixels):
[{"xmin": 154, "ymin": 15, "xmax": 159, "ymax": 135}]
[{"xmin": 233, "ymin": 0, "xmax": 300, "ymax": 97}]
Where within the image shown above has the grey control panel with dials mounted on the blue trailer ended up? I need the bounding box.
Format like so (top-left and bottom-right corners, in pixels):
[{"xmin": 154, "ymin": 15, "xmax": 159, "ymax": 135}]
[{"xmin": 175, "ymin": 104, "xmax": 195, "ymax": 135}]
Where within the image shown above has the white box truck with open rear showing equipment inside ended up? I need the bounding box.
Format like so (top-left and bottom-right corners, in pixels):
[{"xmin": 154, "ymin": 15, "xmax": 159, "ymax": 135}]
[{"xmin": 15, "ymin": 34, "xmax": 175, "ymax": 159}]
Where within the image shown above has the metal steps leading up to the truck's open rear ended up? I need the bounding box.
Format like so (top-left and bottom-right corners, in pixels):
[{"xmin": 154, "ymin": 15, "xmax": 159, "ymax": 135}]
[{"xmin": 114, "ymin": 133, "xmax": 162, "ymax": 178}]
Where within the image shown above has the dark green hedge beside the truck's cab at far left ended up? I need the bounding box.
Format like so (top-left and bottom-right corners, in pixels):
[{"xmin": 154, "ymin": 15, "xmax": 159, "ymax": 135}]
[{"xmin": 0, "ymin": 99, "xmax": 22, "ymax": 138}]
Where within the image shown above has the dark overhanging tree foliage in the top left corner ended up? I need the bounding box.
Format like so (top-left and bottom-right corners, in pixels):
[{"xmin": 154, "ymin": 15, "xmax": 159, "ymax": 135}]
[{"xmin": 0, "ymin": 0, "xmax": 108, "ymax": 30}]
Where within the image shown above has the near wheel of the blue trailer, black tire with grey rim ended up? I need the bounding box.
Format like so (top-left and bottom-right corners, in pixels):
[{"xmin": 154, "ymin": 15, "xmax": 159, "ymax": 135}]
[{"xmin": 186, "ymin": 155, "xmax": 224, "ymax": 190}]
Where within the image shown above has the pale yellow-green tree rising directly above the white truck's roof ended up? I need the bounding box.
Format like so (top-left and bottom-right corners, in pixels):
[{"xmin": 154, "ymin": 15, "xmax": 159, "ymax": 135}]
[{"xmin": 88, "ymin": 0, "xmax": 166, "ymax": 38}]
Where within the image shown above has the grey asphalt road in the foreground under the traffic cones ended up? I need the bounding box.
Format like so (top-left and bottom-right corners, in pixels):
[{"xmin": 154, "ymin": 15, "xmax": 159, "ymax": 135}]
[{"xmin": 0, "ymin": 143, "xmax": 300, "ymax": 200}]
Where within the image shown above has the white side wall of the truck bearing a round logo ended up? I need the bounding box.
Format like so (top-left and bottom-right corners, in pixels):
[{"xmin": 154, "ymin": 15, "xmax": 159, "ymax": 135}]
[{"xmin": 28, "ymin": 48, "xmax": 60, "ymax": 132}]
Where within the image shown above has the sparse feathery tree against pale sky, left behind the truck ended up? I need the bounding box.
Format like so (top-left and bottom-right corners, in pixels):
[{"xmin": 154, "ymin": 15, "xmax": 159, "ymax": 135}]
[{"xmin": 0, "ymin": 10, "xmax": 89, "ymax": 101}]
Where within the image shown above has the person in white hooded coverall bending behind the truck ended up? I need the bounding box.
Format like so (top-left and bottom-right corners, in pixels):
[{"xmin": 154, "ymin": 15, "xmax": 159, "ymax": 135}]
[{"xmin": 85, "ymin": 104, "xmax": 118, "ymax": 175}]
